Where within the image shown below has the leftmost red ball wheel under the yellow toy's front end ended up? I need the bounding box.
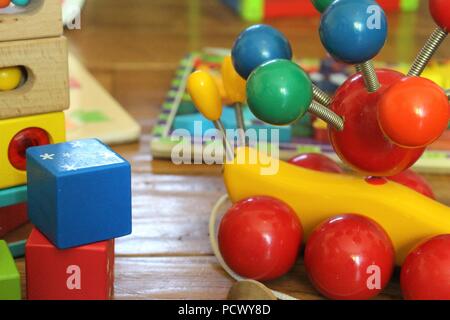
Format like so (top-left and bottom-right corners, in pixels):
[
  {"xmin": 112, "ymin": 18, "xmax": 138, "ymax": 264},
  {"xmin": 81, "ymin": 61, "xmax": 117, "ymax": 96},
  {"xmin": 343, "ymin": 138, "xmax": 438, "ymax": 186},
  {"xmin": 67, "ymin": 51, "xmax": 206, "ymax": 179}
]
[{"xmin": 219, "ymin": 197, "xmax": 303, "ymax": 281}]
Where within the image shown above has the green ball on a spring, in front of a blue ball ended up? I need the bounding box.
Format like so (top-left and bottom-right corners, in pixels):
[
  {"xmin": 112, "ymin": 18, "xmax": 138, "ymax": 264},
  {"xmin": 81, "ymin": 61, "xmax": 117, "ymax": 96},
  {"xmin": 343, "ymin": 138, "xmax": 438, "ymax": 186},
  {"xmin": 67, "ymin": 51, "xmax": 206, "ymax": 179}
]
[{"xmin": 247, "ymin": 60, "xmax": 313, "ymax": 125}]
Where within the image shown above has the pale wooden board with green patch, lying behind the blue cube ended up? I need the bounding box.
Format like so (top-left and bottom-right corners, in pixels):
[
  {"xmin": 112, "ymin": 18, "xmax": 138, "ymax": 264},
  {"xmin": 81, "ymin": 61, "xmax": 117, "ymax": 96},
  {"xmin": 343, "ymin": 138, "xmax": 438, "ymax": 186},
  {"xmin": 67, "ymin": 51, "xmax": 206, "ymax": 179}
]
[{"xmin": 65, "ymin": 54, "xmax": 141, "ymax": 144}]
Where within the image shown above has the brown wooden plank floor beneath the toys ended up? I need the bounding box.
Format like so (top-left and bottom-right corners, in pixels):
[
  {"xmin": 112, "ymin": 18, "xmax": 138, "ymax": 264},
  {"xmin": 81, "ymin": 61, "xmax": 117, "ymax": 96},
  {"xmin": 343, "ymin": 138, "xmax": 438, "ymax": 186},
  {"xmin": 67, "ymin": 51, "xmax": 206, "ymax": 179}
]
[{"xmin": 7, "ymin": 0, "xmax": 450, "ymax": 299}]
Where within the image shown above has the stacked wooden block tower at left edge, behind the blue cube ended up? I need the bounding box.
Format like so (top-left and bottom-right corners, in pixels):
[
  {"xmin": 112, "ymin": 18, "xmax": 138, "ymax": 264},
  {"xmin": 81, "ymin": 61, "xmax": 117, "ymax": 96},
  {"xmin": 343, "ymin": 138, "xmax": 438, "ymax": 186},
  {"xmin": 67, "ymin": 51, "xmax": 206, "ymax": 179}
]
[{"xmin": 0, "ymin": 0, "xmax": 69, "ymax": 299}]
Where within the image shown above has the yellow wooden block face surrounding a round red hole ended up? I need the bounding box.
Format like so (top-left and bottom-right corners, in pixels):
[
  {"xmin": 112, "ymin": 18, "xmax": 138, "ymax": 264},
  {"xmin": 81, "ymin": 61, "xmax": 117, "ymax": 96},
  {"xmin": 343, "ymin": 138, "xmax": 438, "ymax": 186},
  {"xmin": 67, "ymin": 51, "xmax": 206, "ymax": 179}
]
[{"xmin": 0, "ymin": 112, "xmax": 66, "ymax": 190}]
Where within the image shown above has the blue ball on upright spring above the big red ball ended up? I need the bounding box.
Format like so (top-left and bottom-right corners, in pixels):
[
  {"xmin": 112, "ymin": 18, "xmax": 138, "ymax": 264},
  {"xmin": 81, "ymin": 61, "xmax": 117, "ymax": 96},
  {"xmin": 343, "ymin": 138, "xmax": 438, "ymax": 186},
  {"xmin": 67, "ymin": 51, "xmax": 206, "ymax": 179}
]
[{"xmin": 319, "ymin": 0, "xmax": 387, "ymax": 64}]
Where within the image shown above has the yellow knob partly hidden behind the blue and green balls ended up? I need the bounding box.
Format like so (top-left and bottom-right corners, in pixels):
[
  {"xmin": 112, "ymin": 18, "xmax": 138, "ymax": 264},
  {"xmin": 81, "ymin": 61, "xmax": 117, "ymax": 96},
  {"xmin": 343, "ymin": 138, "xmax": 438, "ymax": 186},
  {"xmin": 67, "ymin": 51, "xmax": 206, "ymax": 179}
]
[{"xmin": 221, "ymin": 56, "xmax": 247, "ymax": 103}]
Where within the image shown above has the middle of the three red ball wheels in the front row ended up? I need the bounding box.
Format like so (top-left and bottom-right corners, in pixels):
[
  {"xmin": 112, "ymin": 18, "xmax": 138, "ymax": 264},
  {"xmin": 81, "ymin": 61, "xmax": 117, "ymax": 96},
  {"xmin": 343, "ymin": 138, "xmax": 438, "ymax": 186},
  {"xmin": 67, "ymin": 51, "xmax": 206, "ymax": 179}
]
[{"xmin": 305, "ymin": 214, "xmax": 395, "ymax": 300}]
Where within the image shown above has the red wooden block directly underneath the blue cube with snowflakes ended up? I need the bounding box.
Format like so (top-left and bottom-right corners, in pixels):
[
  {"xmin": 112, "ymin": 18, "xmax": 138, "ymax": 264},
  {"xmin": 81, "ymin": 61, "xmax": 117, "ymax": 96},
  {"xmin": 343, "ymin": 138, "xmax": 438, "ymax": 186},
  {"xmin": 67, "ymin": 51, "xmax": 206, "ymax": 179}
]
[{"xmin": 25, "ymin": 228, "xmax": 114, "ymax": 300}]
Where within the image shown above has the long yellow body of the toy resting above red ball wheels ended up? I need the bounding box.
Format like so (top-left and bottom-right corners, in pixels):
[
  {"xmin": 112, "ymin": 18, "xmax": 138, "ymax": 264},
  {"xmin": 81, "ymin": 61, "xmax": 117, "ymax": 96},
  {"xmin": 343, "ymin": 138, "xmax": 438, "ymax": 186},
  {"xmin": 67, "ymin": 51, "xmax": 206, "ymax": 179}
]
[{"xmin": 223, "ymin": 148, "xmax": 450, "ymax": 265}]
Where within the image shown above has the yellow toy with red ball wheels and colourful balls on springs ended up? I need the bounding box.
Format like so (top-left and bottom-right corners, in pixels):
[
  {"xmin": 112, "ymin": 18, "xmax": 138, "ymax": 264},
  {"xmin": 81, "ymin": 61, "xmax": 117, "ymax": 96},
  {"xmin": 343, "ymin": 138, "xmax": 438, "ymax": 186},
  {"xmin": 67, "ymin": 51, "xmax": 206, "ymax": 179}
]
[{"xmin": 189, "ymin": 0, "xmax": 450, "ymax": 299}]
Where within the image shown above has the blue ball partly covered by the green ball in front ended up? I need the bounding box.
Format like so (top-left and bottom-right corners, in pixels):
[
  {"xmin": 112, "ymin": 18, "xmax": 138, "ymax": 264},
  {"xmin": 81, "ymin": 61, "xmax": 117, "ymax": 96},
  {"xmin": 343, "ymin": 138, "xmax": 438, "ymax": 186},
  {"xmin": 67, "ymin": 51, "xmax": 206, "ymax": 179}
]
[{"xmin": 231, "ymin": 24, "xmax": 292, "ymax": 79}]
